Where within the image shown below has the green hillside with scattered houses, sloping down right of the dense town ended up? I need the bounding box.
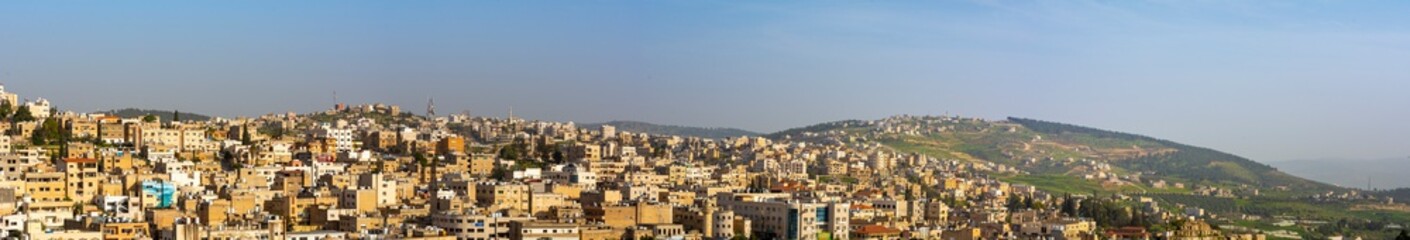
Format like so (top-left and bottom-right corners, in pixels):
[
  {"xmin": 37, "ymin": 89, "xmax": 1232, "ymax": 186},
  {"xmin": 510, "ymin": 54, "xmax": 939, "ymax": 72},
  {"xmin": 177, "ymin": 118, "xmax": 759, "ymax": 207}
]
[{"xmin": 767, "ymin": 116, "xmax": 1410, "ymax": 239}]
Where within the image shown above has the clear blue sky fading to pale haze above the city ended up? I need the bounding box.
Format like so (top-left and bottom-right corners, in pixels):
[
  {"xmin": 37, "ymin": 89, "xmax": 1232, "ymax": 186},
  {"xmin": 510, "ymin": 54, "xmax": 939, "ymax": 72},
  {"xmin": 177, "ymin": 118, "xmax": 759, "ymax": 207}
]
[{"xmin": 0, "ymin": 0, "xmax": 1410, "ymax": 161}]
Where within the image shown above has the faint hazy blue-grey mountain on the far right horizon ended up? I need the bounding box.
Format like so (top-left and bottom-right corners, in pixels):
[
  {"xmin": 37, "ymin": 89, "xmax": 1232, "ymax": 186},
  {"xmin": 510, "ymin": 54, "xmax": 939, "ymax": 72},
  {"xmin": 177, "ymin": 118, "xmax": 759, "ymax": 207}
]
[{"xmin": 1269, "ymin": 158, "xmax": 1410, "ymax": 190}]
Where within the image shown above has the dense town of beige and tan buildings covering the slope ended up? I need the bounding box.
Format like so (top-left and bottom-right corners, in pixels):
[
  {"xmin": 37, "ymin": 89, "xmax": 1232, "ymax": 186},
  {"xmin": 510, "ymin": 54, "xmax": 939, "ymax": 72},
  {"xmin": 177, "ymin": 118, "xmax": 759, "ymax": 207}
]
[{"xmin": 0, "ymin": 86, "xmax": 1353, "ymax": 240}]
